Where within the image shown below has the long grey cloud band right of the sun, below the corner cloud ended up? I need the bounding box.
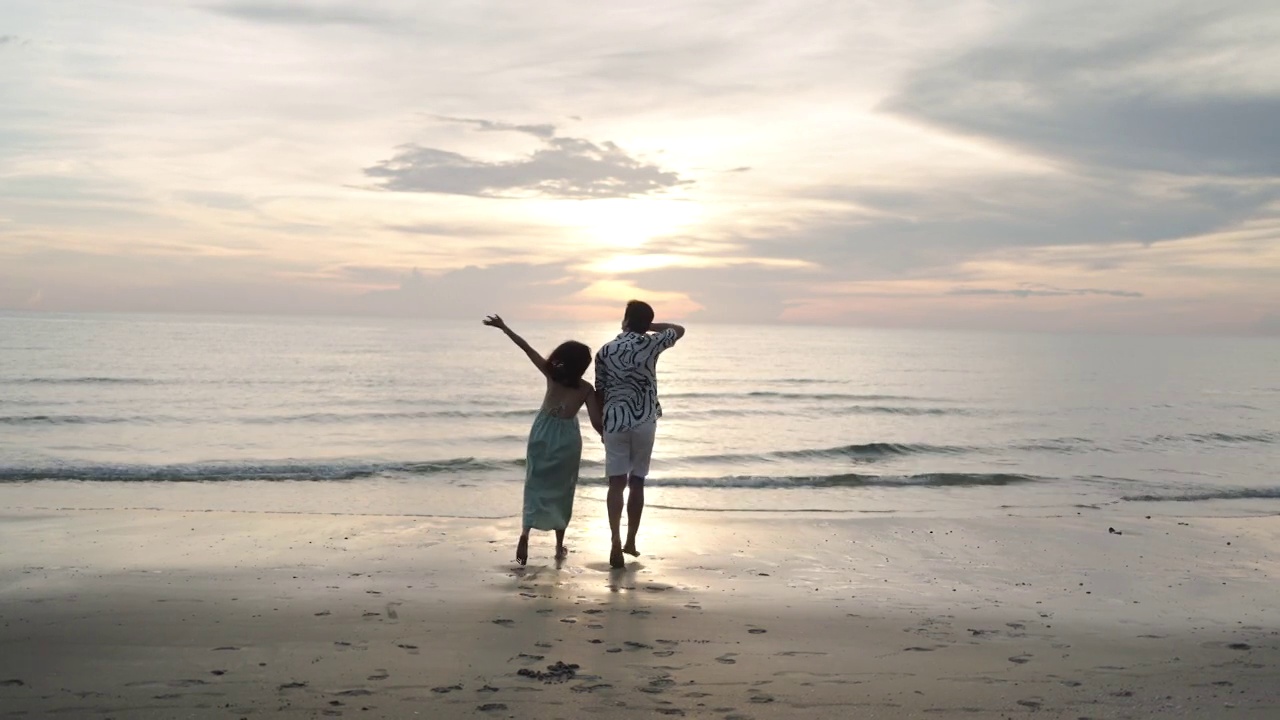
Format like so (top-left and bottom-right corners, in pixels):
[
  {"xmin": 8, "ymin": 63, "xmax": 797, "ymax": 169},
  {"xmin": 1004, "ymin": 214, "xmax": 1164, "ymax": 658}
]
[{"xmin": 735, "ymin": 174, "xmax": 1280, "ymax": 277}]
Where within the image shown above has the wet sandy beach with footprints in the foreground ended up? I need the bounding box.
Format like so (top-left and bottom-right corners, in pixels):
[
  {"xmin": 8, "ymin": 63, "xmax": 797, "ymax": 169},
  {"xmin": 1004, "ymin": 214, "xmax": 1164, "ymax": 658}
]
[{"xmin": 0, "ymin": 483, "xmax": 1280, "ymax": 720}]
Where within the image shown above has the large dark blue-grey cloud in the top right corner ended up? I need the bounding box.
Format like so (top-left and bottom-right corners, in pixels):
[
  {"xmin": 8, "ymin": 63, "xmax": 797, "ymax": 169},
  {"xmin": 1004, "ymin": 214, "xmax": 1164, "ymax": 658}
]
[{"xmin": 883, "ymin": 3, "xmax": 1280, "ymax": 177}]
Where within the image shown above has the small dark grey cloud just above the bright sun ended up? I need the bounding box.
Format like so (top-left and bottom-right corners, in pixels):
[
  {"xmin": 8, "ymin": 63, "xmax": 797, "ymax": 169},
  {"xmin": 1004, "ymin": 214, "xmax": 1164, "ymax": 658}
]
[{"xmin": 365, "ymin": 133, "xmax": 687, "ymax": 199}]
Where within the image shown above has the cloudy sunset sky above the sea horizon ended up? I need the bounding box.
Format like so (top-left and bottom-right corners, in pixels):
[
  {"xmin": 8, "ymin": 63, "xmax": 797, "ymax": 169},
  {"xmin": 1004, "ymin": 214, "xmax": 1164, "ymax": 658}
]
[{"xmin": 0, "ymin": 0, "xmax": 1280, "ymax": 334}]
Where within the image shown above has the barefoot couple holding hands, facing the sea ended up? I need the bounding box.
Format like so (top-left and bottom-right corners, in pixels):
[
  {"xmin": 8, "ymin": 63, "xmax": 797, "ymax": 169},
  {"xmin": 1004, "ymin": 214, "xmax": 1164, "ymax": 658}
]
[{"xmin": 484, "ymin": 300, "xmax": 685, "ymax": 568}]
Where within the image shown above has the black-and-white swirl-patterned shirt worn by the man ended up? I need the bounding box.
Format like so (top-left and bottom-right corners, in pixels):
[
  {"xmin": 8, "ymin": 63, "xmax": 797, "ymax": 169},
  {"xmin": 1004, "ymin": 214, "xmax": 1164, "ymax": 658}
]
[{"xmin": 595, "ymin": 328, "xmax": 678, "ymax": 433}]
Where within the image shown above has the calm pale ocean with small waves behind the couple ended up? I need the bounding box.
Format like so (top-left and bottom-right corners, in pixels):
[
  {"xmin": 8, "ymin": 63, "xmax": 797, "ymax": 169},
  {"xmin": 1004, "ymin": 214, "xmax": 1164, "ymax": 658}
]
[{"xmin": 0, "ymin": 309, "xmax": 1280, "ymax": 518}]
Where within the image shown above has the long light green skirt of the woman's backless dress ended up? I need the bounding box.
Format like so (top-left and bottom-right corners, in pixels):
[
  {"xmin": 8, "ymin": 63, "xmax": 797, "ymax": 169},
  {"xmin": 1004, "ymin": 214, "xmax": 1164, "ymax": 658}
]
[{"xmin": 525, "ymin": 407, "xmax": 582, "ymax": 530}]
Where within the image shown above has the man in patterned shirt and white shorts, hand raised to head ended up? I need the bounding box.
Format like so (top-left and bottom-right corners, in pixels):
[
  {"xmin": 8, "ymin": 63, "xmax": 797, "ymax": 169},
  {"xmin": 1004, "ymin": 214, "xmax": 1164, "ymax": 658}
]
[{"xmin": 595, "ymin": 300, "xmax": 685, "ymax": 568}]
